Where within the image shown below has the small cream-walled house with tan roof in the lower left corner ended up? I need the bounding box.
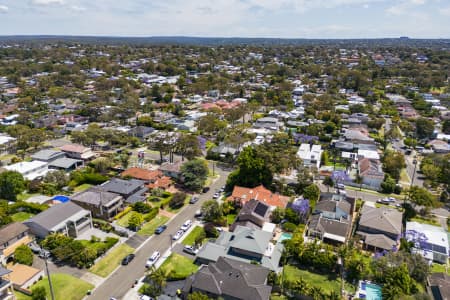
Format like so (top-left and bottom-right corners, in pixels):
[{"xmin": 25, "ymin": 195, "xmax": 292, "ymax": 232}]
[{"xmin": 6, "ymin": 264, "xmax": 44, "ymax": 292}]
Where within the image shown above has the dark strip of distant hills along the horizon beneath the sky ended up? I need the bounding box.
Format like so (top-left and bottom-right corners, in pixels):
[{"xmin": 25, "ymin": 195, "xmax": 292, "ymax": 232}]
[{"xmin": 0, "ymin": 35, "xmax": 450, "ymax": 48}]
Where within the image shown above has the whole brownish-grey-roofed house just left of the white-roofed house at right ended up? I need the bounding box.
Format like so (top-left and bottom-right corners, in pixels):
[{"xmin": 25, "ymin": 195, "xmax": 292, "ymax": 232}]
[{"xmin": 356, "ymin": 205, "xmax": 403, "ymax": 251}]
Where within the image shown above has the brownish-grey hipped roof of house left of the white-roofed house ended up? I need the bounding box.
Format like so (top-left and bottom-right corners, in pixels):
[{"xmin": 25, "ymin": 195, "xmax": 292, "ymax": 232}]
[{"xmin": 359, "ymin": 205, "xmax": 403, "ymax": 235}]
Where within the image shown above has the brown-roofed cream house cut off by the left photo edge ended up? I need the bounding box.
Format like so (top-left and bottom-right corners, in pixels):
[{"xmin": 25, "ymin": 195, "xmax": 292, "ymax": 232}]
[{"xmin": 0, "ymin": 222, "xmax": 33, "ymax": 264}]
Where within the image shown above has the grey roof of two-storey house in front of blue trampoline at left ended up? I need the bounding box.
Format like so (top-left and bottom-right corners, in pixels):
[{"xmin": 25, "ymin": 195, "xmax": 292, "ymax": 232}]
[{"xmin": 24, "ymin": 201, "xmax": 89, "ymax": 230}]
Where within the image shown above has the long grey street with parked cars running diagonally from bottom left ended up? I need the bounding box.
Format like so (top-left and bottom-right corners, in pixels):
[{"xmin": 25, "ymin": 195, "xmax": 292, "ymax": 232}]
[{"xmin": 87, "ymin": 166, "xmax": 229, "ymax": 300}]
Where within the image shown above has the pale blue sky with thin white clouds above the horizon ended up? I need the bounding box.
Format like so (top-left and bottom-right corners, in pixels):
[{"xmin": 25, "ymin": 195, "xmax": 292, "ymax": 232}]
[{"xmin": 0, "ymin": 0, "xmax": 450, "ymax": 38}]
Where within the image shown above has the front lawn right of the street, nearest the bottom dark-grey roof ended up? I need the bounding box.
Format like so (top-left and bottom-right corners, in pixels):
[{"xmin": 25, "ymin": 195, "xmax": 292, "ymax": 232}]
[{"xmin": 161, "ymin": 253, "xmax": 198, "ymax": 281}]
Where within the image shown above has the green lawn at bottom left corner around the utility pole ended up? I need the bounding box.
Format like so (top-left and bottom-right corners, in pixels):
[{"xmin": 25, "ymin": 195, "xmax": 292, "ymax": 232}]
[{"xmin": 15, "ymin": 273, "xmax": 94, "ymax": 300}]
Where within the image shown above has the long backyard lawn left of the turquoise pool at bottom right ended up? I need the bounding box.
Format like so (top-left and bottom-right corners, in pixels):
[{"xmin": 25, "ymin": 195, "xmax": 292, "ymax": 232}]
[{"xmin": 284, "ymin": 265, "xmax": 354, "ymax": 294}]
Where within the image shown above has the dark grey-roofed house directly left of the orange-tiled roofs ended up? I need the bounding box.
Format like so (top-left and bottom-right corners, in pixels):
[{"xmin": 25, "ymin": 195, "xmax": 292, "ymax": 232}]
[{"xmin": 101, "ymin": 178, "xmax": 148, "ymax": 204}]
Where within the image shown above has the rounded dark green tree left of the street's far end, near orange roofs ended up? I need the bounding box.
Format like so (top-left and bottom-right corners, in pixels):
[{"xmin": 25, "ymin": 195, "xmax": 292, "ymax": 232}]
[{"xmin": 181, "ymin": 159, "xmax": 209, "ymax": 191}]
